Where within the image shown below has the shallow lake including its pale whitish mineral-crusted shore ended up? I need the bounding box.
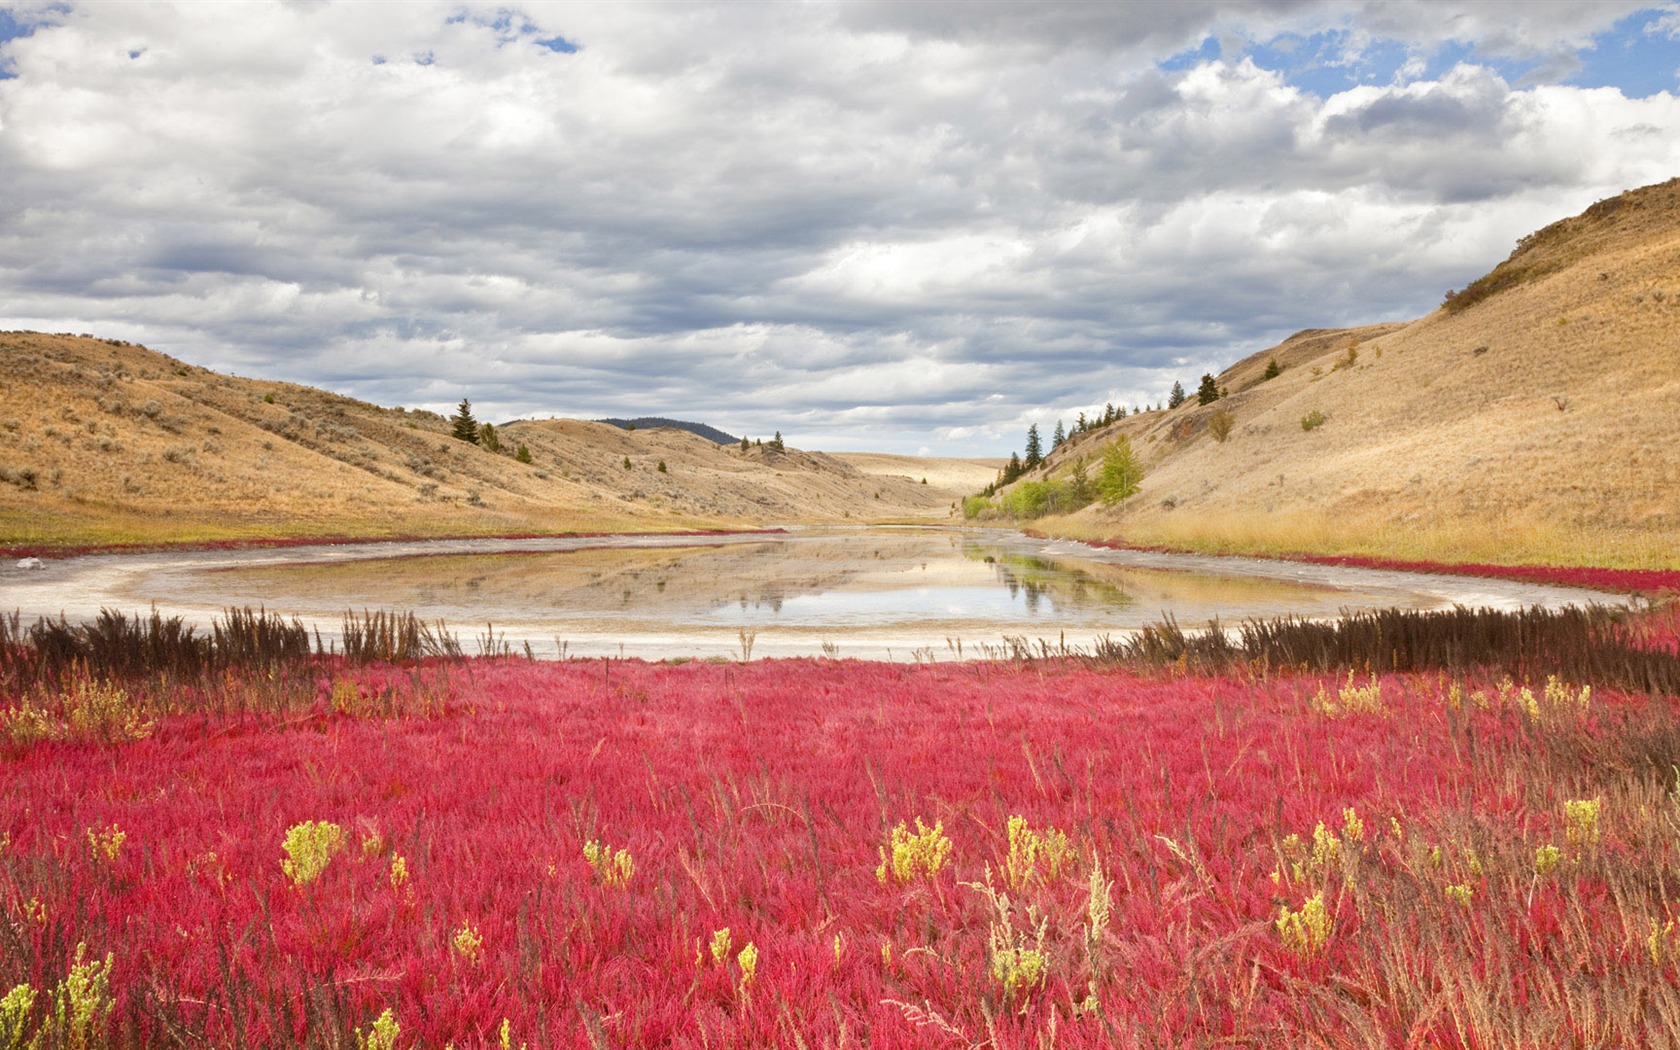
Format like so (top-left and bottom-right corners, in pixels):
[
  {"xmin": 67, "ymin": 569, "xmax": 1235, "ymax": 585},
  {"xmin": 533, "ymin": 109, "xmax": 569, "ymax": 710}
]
[{"xmin": 0, "ymin": 528, "xmax": 1616, "ymax": 659}]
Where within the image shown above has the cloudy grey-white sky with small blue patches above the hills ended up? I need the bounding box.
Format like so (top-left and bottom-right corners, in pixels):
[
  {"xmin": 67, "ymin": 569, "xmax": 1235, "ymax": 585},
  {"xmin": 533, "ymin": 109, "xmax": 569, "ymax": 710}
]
[{"xmin": 0, "ymin": 0, "xmax": 1680, "ymax": 455}]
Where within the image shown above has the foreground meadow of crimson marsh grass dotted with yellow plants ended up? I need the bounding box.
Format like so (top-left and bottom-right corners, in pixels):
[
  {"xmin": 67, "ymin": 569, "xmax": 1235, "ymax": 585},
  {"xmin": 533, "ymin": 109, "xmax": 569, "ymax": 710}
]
[{"xmin": 0, "ymin": 601, "xmax": 1680, "ymax": 1048}]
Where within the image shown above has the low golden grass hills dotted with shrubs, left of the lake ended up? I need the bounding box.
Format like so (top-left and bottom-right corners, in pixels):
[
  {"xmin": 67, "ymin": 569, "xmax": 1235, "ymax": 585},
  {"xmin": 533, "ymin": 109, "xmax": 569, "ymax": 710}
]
[{"xmin": 0, "ymin": 333, "xmax": 993, "ymax": 546}]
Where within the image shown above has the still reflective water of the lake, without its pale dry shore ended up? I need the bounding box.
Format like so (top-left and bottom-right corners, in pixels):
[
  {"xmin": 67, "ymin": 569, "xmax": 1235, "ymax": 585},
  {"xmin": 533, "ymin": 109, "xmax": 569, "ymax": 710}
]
[{"xmin": 160, "ymin": 529, "xmax": 1377, "ymax": 633}]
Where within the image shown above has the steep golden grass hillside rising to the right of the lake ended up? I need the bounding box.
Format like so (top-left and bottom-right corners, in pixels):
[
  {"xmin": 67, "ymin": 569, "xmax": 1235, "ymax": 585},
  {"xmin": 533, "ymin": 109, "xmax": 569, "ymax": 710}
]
[{"xmin": 1014, "ymin": 180, "xmax": 1680, "ymax": 568}]
